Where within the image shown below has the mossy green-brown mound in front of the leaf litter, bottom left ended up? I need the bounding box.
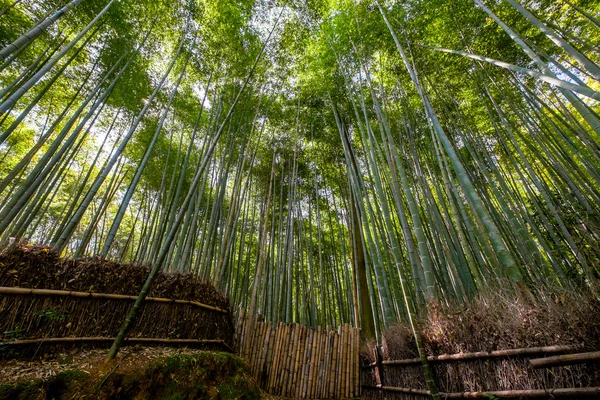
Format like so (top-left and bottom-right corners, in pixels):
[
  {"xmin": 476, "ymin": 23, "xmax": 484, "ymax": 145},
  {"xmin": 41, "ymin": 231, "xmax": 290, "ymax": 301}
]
[{"xmin": 0, "ymin": 352, "xmax": 255, "ymax": 400}]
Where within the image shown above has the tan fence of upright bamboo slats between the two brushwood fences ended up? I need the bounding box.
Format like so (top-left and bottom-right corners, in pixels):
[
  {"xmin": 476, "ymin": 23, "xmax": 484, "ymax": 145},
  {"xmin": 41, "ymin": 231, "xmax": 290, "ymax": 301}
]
[{"xmin": 235, "ymin": 311, "xmax": 360, "ymax": 399}]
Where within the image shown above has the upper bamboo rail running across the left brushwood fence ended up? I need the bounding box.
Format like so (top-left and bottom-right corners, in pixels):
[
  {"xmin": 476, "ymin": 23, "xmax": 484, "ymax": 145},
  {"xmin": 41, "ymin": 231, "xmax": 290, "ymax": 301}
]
[{"xmin": 0, "ymin": 287, "xmax": 228, "ymax": 313}]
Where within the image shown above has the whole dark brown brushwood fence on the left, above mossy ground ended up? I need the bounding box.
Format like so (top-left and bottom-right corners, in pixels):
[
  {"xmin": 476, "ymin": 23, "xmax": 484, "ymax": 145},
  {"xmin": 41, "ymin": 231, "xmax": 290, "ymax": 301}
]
[{"xmin": 0, "ymin": 246, "xmax": 233, "ymax": 356}]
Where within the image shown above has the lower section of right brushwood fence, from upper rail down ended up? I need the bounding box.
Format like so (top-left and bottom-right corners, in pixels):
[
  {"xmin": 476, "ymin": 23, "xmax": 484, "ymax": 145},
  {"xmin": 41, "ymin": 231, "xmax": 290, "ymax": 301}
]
[{"xmin": 361, "ymin": 344, "xmax": 600, "ymax": 400}]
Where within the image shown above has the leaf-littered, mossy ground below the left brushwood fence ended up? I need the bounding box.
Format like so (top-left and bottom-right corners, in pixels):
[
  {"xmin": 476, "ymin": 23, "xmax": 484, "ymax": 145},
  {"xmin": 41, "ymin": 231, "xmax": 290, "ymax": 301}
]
[{"xmin": 0, "ymin": 346, "xmax": 260, "ymax": 400}]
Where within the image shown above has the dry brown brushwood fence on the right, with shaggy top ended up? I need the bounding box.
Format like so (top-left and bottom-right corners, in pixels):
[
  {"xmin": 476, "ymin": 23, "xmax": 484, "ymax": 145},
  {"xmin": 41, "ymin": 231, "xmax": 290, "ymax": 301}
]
[{"xmin": 362, "ymin": 291, "xmax": 600, "ymax": 399}]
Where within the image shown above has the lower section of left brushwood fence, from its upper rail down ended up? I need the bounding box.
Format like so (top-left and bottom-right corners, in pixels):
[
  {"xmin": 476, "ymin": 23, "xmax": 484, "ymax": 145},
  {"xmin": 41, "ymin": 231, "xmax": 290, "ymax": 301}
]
[{"xmin": 0, "ymin": 287, "xmax": 234, "ymax": 350}]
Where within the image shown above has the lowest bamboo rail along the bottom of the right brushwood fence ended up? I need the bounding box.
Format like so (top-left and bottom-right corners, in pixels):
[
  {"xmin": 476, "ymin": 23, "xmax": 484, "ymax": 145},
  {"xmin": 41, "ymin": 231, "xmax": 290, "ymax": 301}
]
[{"xmin": 364, "ymin": 386, "xmax": 600, "ymax": 399}]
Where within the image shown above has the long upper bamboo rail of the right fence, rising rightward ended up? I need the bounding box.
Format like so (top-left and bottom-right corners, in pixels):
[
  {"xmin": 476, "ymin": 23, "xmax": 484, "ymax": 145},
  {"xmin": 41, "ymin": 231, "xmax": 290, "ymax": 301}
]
[{"xmin": 364, "ymin": 345, "xmax": 583, "ymax": 368}]
